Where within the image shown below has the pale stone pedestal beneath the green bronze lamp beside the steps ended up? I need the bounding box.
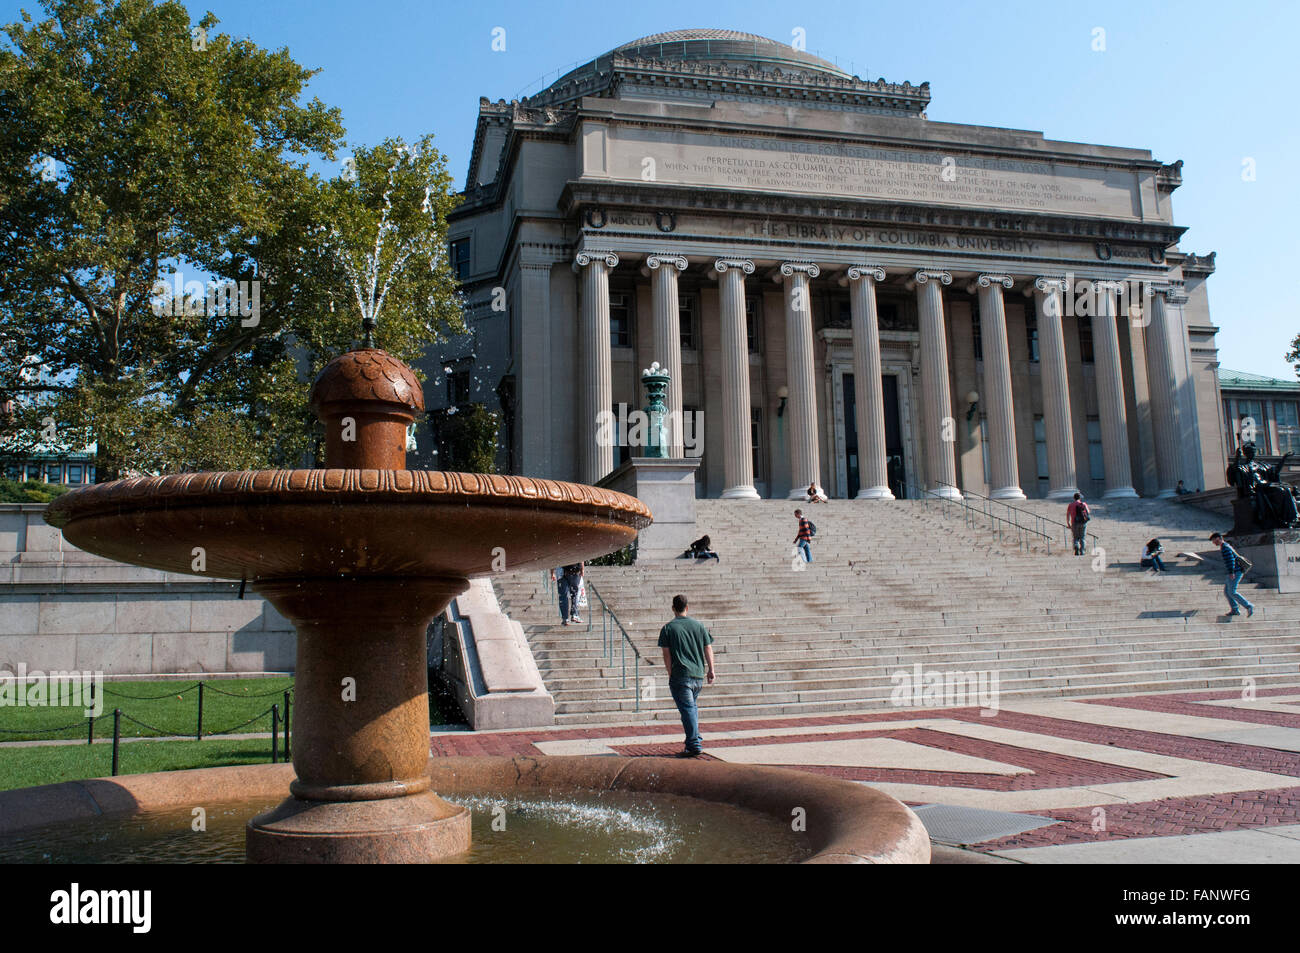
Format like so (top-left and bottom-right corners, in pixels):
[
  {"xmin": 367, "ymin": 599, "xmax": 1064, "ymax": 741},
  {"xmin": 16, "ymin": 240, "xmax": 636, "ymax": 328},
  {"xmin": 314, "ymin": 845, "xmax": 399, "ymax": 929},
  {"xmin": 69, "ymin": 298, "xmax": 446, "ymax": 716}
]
[{"xmin": 597, "ymin": 456, "xmax": 707, "ymax": 562}]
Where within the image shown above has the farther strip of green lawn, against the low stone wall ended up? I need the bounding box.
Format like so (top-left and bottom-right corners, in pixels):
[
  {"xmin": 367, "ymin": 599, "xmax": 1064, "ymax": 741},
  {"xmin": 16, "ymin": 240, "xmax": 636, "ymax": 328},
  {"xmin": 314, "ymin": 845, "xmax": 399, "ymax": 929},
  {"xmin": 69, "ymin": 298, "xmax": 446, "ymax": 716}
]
[{"xmin": 0, "ymin": 676, "xmax": 294, "ymax": 743}]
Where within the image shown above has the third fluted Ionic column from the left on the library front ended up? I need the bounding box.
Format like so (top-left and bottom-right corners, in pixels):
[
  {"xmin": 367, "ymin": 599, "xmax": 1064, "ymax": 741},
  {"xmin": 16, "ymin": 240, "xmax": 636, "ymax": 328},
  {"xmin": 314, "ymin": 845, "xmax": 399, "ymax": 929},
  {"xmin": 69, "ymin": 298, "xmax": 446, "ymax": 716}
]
[{"xmin": 714, "ymin": 259, "xmax": 758, "ymax": 499}]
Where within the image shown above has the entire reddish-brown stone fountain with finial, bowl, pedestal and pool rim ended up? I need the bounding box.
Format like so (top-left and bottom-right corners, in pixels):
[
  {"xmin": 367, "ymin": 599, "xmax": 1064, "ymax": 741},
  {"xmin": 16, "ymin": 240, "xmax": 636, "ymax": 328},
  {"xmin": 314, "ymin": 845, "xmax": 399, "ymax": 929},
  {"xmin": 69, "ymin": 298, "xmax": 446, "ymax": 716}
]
[{"xmin": 27, "ymin": 343, "xmax": 930, "ymax": 862}]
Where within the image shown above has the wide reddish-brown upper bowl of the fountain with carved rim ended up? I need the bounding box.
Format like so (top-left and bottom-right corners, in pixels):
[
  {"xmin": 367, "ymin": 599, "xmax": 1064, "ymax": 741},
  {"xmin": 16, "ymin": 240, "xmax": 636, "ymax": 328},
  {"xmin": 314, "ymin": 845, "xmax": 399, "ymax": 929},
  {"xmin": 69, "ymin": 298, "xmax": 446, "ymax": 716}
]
[{"xmin": 46, "ymin": 469, "xmax": 650, "ymax": 580}]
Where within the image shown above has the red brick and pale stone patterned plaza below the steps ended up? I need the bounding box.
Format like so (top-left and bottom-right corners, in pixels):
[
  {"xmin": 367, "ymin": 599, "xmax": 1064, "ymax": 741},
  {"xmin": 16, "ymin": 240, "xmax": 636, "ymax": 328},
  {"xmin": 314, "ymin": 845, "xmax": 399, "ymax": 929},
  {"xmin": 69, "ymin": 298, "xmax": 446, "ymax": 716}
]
[{"xmin": 433, "ymin": 684, "xmax": 1300, "ymax": 863}]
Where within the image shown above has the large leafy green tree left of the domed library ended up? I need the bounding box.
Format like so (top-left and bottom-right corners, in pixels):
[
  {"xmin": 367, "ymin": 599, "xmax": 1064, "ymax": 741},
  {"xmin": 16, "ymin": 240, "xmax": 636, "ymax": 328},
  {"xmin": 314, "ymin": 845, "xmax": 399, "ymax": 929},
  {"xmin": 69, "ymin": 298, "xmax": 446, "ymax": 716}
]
[{"xmin": 0, "ymin": 0, "xmax": 459, "ymax": 480}]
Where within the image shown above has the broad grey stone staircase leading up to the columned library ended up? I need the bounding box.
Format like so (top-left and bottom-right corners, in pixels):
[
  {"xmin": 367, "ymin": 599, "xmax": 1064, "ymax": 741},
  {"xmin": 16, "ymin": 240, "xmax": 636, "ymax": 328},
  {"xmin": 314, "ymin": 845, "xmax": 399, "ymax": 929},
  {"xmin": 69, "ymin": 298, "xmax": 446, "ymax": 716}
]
[{"xmin": 495, "ymin": 501, "xmax": 1300, "ymax": 723}]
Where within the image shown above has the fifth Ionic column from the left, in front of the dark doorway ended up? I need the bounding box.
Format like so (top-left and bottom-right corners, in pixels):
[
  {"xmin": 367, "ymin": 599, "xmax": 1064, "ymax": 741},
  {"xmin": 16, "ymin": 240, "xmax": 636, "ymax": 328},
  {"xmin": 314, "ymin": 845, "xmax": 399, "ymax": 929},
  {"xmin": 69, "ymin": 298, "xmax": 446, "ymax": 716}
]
[{"xmin": 849, "ymin": 265, "xmax": 893, "ymax": 499}]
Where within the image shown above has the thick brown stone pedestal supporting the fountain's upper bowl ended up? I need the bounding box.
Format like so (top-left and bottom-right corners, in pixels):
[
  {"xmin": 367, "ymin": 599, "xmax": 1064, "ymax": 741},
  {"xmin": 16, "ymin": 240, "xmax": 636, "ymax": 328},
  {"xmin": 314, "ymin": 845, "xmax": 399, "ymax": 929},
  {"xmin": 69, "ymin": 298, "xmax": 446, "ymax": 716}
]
[{"xmin": 248, "ymin": 576, "xmax": 469, "ymax": 863}]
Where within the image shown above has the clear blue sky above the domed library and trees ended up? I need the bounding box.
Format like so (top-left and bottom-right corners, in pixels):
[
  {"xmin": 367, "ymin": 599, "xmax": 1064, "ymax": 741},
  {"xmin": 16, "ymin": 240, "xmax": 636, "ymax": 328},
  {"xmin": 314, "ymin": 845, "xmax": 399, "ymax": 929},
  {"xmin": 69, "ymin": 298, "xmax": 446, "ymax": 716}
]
[{"xmin": 10, "ymin": 0, "xmax": 1300, "ymax": 377}]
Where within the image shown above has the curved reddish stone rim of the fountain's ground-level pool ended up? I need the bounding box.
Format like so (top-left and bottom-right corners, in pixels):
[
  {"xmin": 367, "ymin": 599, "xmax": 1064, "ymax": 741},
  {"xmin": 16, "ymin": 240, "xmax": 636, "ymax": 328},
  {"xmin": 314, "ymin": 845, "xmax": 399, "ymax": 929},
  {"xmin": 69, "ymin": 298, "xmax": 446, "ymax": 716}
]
[{"xmin": 0, "ymin": 755, "xmax": 930, "ymax": 863}]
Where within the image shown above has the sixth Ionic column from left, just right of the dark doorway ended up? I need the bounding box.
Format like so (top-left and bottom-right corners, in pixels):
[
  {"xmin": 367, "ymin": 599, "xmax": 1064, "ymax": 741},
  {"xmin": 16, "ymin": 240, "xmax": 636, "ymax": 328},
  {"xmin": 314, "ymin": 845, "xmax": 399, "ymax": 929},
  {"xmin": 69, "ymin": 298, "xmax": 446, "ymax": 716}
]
[{"xmin": 917, "ymin": 269, "xmax": 962, "ymax": 499}]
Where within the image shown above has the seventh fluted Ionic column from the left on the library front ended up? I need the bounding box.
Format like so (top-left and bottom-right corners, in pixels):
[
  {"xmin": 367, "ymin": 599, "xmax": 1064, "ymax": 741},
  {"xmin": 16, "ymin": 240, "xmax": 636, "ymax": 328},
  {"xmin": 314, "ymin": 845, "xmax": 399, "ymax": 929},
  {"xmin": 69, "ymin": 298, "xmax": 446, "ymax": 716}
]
[{"xmin": 978, "ymin": 274, "xmax": 1024, "ymax": 499}]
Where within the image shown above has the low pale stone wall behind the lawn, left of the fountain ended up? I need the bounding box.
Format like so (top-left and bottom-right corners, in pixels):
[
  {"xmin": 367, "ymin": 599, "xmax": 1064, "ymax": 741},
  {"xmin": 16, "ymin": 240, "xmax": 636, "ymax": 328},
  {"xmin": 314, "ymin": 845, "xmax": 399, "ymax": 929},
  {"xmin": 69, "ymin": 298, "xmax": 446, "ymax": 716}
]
[{"xmin": 0, "ymin": 503, "xmax": 295, "ymax": 675}]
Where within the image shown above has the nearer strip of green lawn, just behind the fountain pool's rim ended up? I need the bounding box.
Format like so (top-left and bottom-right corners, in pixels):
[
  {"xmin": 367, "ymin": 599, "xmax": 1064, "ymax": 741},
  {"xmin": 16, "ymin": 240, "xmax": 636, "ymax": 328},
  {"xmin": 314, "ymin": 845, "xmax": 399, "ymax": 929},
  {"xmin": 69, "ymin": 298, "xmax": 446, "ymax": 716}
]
[{"xmin": 0, "ymin": 738, "xmax": 285, "ymax": 790}]
